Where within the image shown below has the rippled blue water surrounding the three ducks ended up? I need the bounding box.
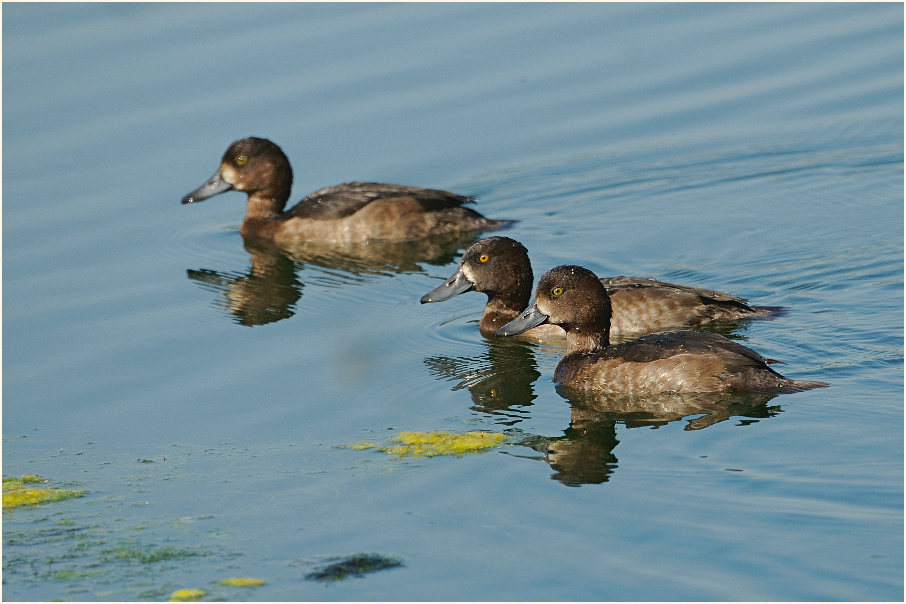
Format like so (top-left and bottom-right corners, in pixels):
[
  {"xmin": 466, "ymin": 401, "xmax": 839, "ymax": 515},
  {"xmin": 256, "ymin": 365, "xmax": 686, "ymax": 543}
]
[{"xmin": 3, "ymin": 4, "xmax": 903, "ymax": 600}]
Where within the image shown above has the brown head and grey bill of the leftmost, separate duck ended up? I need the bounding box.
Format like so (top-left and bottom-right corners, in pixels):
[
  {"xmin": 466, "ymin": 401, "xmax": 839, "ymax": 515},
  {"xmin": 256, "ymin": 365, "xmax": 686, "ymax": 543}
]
[{"xmin": 182, "ymin": 137, "xmax": 293, "ymax": 212}]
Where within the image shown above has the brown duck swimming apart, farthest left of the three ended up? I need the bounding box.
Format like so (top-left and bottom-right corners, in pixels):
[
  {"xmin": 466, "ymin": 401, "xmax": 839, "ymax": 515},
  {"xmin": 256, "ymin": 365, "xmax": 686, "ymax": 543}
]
[{"xmin": 182, "ymin": 137, "xmax": 504, "ymax": 245}]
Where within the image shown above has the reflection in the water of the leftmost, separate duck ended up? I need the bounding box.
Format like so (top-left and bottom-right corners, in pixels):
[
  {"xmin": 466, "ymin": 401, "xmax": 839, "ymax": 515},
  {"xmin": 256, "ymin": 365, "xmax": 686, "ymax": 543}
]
[{"xmin": 186, "ymin": 233, "xmax": 478, "ymax": 326}]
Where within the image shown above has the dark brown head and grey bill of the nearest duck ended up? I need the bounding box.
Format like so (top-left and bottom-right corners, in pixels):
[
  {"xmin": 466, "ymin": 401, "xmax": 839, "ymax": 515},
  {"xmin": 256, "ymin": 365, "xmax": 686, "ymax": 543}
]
[{"xmin": 497, "ymin": 265, "xmax": 611, "ymax": 352}]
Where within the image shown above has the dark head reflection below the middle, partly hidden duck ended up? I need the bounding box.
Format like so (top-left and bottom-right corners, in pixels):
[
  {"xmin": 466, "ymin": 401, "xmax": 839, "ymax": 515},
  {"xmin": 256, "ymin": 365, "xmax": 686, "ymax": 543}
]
[{"xmin": 425, "ymin": 338, "xmax": 541, "ymax": 425}]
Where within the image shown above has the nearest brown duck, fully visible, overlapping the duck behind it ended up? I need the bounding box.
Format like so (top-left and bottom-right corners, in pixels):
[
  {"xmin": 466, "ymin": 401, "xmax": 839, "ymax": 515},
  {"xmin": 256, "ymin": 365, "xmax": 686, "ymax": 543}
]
[{"xmin": 497, "ymin": 265, "xmax": 828, "ymax": 395}]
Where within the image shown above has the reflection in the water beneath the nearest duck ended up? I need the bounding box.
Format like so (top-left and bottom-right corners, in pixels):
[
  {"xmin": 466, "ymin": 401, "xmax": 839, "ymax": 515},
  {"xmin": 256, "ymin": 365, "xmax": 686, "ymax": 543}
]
[{"xmin": 521, "ymin": 386, "xmax": 781, "ymax": 486}]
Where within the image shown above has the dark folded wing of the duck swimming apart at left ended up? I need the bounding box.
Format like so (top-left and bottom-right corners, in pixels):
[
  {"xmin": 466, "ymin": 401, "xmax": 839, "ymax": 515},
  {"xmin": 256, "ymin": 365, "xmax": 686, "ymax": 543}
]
[{"xmin": 286, "ymin": 182, "xmax": 474, "ymax": 220}]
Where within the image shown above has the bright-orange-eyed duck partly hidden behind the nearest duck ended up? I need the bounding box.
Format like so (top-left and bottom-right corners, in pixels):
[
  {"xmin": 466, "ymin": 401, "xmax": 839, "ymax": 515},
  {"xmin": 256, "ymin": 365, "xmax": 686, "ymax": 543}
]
[{"xmin": 420, "ymin": 236, "xmax": 782, "ymax": 340}]
